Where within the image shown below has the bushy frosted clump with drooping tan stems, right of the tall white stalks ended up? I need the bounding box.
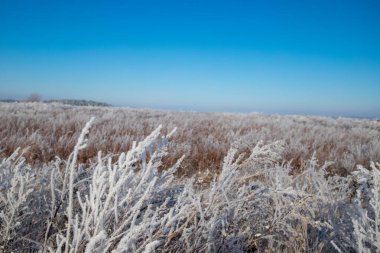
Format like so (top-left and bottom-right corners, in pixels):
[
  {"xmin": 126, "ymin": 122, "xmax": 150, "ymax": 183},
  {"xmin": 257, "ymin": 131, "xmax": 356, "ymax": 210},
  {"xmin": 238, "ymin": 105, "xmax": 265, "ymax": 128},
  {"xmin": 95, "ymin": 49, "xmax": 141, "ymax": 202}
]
[{"xmin": 151, "ymin": 142, "xmax": 349, "ymax": 252}]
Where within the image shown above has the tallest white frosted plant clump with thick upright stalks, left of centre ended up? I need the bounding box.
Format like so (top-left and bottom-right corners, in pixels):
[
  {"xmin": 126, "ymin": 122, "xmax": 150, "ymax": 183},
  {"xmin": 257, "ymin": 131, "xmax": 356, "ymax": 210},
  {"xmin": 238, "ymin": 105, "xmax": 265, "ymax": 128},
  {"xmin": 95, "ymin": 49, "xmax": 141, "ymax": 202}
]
[{"xmin": 43, "ymin": 122, "xmax": 182, "ymax": 252}]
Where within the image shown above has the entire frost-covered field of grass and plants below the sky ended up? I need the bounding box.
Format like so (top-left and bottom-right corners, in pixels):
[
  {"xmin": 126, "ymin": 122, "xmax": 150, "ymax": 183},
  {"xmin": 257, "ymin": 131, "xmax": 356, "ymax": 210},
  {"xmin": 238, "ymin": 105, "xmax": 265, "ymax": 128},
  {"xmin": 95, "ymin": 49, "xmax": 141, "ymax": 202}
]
[{"xmin": 0, "ymin": 103, "xmax": 380, "ymax": 253}]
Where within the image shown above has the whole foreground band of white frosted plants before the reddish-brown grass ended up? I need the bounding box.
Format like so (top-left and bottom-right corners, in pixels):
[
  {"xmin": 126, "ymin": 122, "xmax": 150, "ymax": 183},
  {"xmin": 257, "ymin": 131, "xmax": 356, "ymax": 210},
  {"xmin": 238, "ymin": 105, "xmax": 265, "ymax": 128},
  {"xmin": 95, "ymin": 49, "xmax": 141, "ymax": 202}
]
[{"xmin": 0, "ymin": 109, "xmax": 380, "ymax": 253}]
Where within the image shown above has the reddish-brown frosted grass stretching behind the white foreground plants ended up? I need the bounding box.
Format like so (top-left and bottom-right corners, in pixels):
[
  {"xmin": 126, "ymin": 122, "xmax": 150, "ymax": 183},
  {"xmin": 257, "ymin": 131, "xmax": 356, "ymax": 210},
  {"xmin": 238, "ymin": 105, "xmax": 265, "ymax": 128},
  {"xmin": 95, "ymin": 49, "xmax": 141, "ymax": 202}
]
[{"xmin": 0, "ymin": 103, "xmax": 380, "ymax": 175}]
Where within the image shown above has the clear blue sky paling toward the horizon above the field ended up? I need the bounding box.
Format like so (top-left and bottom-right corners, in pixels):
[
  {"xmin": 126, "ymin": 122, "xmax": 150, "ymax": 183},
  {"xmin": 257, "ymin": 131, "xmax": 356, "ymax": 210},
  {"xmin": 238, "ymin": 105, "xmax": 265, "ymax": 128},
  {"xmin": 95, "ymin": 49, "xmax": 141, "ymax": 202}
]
[{"xmin": 0, "ymin": 0, "xmax": 380, "ymax": 117}]
